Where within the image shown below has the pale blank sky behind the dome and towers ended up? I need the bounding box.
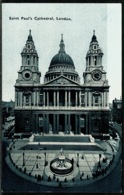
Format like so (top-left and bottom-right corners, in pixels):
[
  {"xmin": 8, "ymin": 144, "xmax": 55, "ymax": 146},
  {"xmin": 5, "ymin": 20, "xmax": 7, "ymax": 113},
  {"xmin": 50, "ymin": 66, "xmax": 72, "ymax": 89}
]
[{"xmin": 2, "ymin": 3, "xmax": 122, "ymax": 103}]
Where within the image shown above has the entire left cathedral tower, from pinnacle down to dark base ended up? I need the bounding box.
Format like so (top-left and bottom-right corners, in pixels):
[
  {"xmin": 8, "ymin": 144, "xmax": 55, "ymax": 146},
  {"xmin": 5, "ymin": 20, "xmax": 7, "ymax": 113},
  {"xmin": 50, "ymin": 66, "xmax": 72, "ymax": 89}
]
[{"xmin": 15, "ymin": 30, "xmax": 41, "ymax": 132}]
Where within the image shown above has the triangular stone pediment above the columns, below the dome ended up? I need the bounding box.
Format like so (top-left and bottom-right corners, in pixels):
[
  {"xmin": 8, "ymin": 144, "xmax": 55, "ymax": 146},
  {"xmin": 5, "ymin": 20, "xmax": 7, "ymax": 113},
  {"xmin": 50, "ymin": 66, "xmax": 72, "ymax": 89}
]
[{"xmin": 45, "ymin": 76, "xmax": 80, "ymax": 86}]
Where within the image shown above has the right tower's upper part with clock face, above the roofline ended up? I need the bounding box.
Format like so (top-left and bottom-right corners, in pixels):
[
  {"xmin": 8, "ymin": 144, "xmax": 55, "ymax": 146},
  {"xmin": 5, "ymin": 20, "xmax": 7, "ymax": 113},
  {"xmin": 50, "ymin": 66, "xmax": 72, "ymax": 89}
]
[{"xmin": 83, "ymin": 31, "xmax": 108, "ymax": 85}]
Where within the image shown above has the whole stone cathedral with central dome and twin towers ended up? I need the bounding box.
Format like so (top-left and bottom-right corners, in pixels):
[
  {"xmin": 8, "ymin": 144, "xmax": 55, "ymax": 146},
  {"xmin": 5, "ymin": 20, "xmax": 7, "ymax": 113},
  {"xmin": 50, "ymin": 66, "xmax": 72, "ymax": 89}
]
[{"xmin": 15, "ymin": 31, "xmax": 109, "ymax": 136}]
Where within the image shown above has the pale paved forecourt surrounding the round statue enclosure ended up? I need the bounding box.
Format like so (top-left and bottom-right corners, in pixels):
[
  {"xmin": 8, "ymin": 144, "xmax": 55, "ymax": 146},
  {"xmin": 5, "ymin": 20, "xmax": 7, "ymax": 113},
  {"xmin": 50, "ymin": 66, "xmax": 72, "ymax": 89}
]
[{"xmin": 7, "ymin": 133, "xmax": 119, "ymax": 186}]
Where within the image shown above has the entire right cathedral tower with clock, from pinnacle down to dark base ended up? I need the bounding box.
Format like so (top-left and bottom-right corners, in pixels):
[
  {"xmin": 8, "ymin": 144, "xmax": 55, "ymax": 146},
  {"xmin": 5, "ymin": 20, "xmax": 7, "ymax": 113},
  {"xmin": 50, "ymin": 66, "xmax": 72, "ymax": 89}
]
[{"xmin": 83, "ymin": 31, "xmax": 109, "ymax": 134}]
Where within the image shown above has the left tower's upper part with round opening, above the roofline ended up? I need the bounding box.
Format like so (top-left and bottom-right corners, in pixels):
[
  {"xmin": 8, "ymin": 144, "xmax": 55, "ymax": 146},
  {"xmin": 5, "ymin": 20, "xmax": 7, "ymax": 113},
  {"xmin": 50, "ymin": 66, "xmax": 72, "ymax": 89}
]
[{"xmin": 16, "ymin": 30, "xmax": 41, "ymax": 84}]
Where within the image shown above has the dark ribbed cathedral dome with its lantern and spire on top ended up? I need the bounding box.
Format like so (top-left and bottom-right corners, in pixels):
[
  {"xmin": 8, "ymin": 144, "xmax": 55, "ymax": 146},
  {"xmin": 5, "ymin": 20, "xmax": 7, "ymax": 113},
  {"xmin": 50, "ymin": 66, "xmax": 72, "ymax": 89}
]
[{"xmin": 50, "ymin": 37, "xmax": 74, "ymax": 66}]
